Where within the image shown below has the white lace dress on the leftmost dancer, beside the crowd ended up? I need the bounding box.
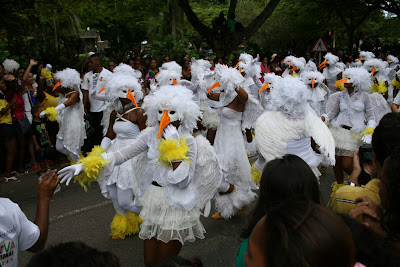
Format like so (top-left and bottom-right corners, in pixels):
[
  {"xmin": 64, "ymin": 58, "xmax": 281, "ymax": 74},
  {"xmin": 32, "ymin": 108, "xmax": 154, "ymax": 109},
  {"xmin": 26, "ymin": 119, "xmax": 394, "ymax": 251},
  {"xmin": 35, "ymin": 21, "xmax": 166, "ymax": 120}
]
[{"xmin": 57, "ymin": 91, "xmax": 86, "ymax": 159}]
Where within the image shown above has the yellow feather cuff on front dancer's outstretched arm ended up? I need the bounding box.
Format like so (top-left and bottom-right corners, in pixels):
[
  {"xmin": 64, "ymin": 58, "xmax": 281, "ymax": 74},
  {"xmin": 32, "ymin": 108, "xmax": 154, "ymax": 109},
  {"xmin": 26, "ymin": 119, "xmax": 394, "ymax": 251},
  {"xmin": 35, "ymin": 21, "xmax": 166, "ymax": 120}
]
[{"xmin": 74, "ymin": 146, "xmax": 110, "ymax": 191}]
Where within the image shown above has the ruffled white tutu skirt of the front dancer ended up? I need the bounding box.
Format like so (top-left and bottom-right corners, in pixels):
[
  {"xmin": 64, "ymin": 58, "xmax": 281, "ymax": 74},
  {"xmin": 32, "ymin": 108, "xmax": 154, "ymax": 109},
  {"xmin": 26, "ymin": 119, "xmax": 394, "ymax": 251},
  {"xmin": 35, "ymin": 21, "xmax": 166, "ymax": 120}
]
[{"xmin": 139, "ymin": 185, "xmax": 206, "ymax": 245}]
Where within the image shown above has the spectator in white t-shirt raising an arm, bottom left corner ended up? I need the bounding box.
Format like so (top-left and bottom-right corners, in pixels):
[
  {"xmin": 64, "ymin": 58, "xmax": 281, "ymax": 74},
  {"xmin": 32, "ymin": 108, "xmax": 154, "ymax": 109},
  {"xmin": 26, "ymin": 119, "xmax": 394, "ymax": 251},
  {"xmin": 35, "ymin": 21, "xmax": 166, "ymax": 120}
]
[{"xmin": 0, "ymin": 170, "xmax": 60, "ymax": 267}]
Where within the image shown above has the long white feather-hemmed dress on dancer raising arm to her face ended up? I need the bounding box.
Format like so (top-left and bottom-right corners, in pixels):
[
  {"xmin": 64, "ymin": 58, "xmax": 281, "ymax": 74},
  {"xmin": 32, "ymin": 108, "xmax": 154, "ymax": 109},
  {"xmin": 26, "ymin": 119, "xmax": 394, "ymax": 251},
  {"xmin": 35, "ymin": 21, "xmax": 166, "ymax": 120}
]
[{"xmin": 214, "ymin": 107, "xmax": 257, "ymax": 218}]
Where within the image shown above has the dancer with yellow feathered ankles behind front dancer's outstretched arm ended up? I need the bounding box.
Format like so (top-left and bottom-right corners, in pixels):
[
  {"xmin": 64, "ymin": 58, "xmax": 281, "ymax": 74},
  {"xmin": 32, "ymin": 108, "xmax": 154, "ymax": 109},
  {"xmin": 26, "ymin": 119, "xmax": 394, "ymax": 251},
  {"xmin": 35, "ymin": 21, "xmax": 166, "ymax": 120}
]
[{"xmin": 93, "ymin": 64, "xmax": 146, "ymax": 239}]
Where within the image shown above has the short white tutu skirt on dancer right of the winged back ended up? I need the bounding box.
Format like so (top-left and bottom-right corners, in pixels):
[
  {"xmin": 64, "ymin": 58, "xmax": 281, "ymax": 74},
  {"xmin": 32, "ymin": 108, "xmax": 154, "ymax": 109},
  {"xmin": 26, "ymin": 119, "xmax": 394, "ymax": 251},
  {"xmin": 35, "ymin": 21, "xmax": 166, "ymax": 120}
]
[{"xmin": 330, "ymin": 127, "xmax": 362, "ymax": 157}]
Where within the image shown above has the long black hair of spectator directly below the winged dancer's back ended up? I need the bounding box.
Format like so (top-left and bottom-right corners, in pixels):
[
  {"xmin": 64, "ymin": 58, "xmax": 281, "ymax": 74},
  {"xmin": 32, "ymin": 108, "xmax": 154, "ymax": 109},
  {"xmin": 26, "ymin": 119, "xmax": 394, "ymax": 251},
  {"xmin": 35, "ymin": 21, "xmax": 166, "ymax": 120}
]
[{"xmin": 241, "ymin": 155, "xmax": 321, "ymax": 238}]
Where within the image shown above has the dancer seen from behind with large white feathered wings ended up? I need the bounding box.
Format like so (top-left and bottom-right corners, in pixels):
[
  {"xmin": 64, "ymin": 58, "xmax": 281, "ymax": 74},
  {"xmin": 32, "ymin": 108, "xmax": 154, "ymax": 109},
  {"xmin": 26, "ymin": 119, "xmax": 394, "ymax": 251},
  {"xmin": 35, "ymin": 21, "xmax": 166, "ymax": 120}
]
[{"xmin": 252, "ymin": 77, "xmax": 335, "ymax": 182}]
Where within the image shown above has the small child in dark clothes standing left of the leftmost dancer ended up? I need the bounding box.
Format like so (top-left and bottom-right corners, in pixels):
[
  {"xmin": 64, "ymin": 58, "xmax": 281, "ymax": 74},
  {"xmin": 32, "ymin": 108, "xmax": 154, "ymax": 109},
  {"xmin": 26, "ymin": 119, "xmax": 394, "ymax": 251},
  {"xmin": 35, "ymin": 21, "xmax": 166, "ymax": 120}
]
[{"xmin": 31, "ymin": 105, "xmax": 51, "ymax": 170}]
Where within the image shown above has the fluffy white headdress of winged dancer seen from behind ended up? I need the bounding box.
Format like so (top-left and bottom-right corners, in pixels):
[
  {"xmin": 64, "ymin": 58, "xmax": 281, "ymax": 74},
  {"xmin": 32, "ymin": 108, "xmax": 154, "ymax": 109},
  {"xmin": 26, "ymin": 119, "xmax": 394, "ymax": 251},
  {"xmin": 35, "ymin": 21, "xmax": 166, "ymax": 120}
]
[{"xmin": 271, "ymin": 77, "xmax": 307, "ymax": 118}]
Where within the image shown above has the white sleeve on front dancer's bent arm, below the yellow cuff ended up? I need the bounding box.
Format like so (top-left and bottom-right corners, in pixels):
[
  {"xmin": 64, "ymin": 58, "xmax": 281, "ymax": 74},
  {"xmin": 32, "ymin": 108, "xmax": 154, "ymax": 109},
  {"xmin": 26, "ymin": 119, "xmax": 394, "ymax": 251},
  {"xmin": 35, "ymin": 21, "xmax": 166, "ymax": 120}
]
[{"xmin": 168, "ymin": 137, "xmax": 197, "ymax": 189}]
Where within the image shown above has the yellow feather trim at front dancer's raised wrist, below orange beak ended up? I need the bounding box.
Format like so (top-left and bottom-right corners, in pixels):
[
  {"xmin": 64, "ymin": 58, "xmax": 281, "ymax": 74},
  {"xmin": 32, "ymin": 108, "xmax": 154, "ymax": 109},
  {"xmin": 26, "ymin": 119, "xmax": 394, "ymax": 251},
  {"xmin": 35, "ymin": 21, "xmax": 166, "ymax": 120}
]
[{"xmin": 158, "ymin": 138, "xmax": 189, "ymax": 166}]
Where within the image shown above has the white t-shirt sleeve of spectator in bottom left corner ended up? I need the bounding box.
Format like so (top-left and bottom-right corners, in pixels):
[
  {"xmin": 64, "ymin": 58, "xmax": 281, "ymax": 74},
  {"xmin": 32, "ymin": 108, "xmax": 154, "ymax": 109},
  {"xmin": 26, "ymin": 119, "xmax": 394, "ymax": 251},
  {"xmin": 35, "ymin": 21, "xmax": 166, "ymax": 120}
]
[{"xmin": 13, "ymin": 203, "xmax": 40, "ymax": 251}]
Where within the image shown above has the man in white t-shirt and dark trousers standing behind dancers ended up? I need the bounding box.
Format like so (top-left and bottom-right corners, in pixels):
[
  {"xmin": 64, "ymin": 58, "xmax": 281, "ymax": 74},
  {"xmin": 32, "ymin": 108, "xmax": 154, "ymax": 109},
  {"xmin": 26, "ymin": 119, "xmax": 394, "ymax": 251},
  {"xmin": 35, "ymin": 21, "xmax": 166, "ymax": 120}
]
[{"xmin": 82, "ymin": 54, "xmax": 112, "ymax": 150}]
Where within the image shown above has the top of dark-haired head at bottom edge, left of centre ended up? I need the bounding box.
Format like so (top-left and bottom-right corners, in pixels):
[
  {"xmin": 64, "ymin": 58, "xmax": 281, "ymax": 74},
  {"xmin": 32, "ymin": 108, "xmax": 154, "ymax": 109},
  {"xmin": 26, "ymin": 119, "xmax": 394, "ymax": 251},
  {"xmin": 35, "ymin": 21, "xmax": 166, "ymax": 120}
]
[{"xmin": 27, "ymin": 242, "xmax": 120, "ymax": 267}]
